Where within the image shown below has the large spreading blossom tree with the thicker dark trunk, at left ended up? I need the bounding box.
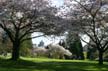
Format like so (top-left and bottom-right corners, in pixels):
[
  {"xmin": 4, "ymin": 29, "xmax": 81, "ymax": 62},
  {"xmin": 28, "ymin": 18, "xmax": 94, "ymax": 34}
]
[{"xmin": 0, "ymin": 0, "xmax": 62, "ymax": 60}]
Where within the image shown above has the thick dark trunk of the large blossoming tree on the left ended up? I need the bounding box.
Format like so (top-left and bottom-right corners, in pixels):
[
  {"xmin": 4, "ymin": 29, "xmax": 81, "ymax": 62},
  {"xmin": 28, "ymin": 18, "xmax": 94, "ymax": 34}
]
[{"xmin": 11, "ymin": 42, "xmax": 20, "ymax": 61}]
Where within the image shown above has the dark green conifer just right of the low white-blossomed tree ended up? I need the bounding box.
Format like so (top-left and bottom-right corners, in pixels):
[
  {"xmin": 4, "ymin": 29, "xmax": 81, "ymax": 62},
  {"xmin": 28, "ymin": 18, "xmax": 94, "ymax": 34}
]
[{"xmin": 67, "ymin": 32, "xmax": 84, "ymax": 59}]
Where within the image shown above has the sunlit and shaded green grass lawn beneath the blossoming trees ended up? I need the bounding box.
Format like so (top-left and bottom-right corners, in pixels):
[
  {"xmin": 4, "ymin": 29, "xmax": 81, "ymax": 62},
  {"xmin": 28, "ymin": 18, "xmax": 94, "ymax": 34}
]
[{"xmin": 0, "ymin": 58, "xmax": 108, "ymax": 71}]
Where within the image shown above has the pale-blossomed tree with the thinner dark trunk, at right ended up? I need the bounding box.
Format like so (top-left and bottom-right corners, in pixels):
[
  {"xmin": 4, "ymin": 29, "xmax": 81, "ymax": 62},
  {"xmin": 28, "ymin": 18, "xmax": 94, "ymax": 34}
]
[{"xmin": 63, "ymin": 0, "xmax": 108, "ymax": 64}]
